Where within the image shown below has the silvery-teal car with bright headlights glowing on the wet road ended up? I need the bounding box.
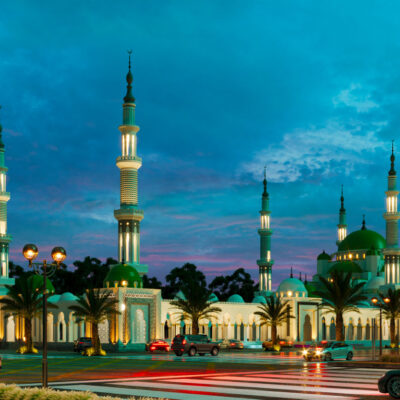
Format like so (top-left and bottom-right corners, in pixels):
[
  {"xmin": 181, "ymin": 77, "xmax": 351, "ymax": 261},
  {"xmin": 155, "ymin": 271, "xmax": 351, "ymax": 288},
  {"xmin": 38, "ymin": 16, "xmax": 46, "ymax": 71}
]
[{"xmin": 303, "ymin": 342, "xmax": 354, "ymax": 361}]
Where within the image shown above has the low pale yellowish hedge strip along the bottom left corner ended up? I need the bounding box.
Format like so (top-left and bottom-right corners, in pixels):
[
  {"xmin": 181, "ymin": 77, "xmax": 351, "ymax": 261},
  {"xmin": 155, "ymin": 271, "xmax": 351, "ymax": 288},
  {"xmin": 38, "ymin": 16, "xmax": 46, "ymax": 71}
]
[{"xmin": 0, "ymin": 383, "xmax": 162, "ymax": 400}]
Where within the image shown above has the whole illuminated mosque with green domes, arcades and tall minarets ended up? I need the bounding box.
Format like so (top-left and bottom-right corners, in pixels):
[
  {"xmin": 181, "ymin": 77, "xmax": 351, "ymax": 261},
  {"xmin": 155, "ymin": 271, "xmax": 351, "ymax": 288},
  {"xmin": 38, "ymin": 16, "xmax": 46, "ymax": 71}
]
[{"xmin": 0, "ymin": 60, "xmax": 400, "ymax": 351}]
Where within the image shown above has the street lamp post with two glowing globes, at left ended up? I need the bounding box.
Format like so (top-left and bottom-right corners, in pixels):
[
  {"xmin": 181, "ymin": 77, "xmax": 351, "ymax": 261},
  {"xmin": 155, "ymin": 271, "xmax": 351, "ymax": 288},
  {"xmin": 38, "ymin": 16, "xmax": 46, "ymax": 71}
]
[{"xmin": 22, "ymin": 244, "xmax": 67, "ymax": 387}]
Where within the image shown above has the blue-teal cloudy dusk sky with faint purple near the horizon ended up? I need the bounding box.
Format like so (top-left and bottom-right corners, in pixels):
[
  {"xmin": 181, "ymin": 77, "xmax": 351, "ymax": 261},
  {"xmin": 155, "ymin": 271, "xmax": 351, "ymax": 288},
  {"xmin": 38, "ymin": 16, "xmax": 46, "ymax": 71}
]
[{"xmin": 0, "ymin": 0, "xmax": 400, "ymax": 287}]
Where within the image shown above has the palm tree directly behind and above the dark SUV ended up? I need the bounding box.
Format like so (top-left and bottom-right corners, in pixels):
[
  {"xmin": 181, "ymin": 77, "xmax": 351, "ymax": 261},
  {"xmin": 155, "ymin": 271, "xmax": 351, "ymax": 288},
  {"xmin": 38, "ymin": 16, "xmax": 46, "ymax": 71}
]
[{"xmin": 170, "ymin": 282, "xmax": 222, "ymax": 335}]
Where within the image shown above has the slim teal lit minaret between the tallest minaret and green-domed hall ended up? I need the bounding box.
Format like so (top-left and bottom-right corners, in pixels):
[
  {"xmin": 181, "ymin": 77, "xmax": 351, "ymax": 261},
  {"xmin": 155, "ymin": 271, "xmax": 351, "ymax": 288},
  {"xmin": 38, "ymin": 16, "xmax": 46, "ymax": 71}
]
[{"xmin": 257, "ymin": 167, "xmax": 274, "ymax": 294}]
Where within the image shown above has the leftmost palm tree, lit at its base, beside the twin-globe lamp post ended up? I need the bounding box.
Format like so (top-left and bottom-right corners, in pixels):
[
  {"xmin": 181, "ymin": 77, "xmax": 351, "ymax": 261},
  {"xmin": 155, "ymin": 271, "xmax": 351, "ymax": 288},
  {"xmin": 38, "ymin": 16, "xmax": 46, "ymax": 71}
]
[{"xmin": 0, "ymin": 278, "xmax": 56, "ymax": 353}]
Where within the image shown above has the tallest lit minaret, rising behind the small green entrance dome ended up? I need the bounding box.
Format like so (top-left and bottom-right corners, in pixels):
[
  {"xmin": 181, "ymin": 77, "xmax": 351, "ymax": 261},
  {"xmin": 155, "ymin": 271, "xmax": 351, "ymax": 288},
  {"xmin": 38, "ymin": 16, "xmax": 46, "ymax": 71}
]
[{"xmin": 114, "ymin": 51, "xmax": 147, "ymax": 274}]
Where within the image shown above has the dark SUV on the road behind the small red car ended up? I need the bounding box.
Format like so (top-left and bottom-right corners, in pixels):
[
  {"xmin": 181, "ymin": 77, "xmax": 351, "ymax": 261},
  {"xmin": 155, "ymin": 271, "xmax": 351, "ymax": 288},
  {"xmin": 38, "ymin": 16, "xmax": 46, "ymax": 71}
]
[{"xmin": 171, "ymin": 335, "xmax": 219, "ymax": 357}]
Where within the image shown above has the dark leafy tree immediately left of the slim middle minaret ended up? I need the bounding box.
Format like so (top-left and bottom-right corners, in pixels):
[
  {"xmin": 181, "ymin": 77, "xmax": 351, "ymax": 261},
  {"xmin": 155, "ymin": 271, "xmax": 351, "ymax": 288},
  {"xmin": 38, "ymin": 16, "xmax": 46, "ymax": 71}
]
[{"xmin": 208, "ymin": 268, "xmax": 257, "ymax": 302}]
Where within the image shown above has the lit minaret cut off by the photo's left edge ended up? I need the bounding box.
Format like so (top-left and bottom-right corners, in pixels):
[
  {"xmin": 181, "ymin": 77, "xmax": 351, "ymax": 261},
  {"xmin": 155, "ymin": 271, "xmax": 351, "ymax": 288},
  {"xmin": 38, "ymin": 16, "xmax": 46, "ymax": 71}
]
[{"xmin": 0, "ymin": 107, "xmax": 14, "ymax": 295}]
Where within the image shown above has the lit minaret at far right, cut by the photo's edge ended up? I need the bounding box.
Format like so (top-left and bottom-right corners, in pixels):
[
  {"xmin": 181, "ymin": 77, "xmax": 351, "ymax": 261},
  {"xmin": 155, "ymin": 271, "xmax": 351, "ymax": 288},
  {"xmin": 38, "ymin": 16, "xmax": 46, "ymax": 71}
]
[{"xmin": 383, "ymin": 141, "xmax": 400, "ymax": 285}]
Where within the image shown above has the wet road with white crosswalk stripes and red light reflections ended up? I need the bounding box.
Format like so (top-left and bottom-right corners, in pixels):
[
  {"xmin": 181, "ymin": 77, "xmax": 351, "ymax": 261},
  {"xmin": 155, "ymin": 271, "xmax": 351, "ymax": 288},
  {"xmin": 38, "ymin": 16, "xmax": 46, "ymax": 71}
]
[{"xmin": 0, "ymin": 352, "xmax": 388, "ymax": 400}]
